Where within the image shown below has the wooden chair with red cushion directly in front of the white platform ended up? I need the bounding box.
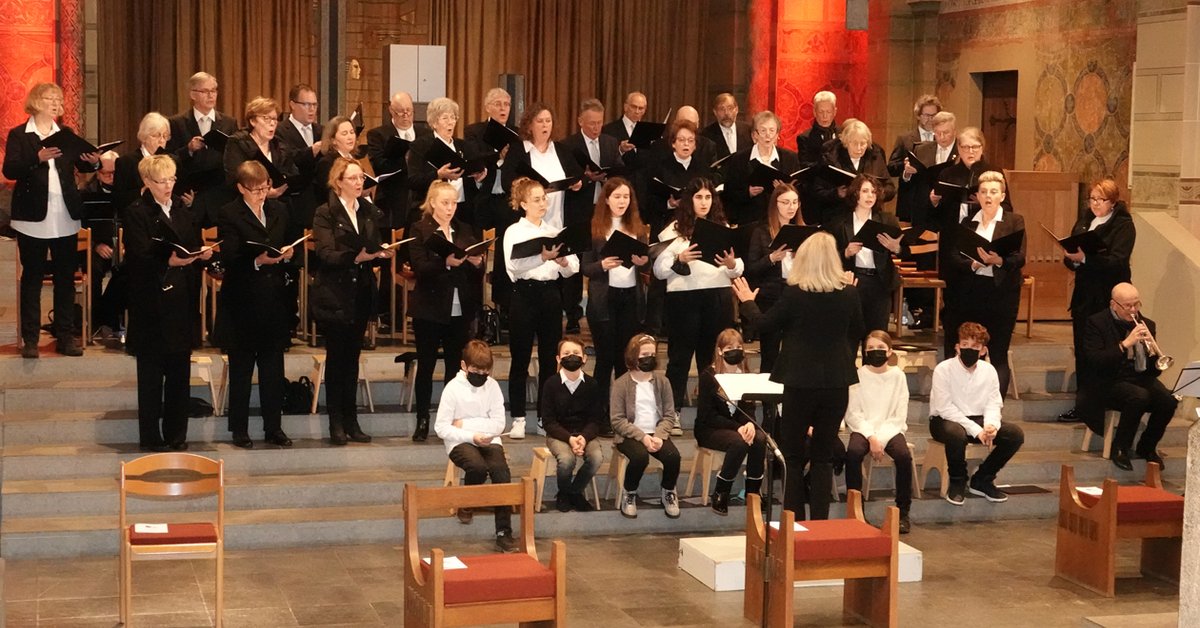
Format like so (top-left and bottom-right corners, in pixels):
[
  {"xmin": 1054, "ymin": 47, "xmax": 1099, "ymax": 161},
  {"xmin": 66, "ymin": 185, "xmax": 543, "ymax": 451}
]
[{"xmin": 743, "ymin": 490, "xmax": 900, "ymax": 628}]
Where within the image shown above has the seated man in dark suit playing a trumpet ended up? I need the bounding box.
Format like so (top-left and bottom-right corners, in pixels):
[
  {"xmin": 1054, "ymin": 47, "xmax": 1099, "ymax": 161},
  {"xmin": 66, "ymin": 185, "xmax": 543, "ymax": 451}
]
[{"xmin": 1076, "ymin": 283, "xmax": 1178, "ymax": 471}]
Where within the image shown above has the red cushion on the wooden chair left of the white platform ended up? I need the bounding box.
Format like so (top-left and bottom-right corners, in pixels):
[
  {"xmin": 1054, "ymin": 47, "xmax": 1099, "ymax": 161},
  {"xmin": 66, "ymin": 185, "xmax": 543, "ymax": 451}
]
[{"xmin": 421, "ymin": 554, "xmax": 556, "ymax": 604}]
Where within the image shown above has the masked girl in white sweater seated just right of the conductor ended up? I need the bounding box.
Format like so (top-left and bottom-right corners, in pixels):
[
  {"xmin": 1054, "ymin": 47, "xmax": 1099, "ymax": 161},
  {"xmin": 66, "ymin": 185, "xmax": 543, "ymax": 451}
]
[{"xmin": 846, "ymin": 329, "xmax": 912, "ymax": 534}]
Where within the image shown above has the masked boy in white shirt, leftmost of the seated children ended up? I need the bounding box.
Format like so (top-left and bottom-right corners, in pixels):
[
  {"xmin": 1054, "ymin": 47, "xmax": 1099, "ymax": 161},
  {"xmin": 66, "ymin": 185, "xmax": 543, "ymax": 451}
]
[{"xmin": 433, "ymin": 340, "xmax": 517, "ymax": 552}]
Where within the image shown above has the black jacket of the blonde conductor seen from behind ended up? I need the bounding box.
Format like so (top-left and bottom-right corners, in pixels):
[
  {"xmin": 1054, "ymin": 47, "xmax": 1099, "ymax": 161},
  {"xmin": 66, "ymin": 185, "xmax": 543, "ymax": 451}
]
[{"xmin": 742, "ymin": 286, "xmax": 866, "ymax": 388}]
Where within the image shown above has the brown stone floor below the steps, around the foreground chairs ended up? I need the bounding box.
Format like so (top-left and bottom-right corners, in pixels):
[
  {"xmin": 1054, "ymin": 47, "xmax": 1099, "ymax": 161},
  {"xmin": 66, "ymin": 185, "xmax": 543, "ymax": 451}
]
[{"xmin": 4, "ymin": 518, "xmax": 1178, "ymax": 628}]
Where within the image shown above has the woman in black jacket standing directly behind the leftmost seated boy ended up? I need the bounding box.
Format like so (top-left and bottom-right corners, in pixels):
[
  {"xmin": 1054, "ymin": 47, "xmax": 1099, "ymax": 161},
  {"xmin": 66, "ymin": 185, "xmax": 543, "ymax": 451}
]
[{"xmin": 408, "ymin": 181, "xmax": 484, "ymax": 442}]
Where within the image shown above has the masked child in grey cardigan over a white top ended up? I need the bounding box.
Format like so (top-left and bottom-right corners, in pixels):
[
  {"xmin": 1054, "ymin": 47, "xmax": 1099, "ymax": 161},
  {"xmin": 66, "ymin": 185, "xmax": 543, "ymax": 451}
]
[{"xmin": 608, "ymin": 334, "xmax": 680, "ymax": 519}]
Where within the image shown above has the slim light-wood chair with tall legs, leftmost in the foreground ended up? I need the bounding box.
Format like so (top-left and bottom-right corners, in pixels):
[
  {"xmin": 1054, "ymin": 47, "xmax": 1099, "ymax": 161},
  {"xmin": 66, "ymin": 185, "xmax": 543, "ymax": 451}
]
[{"xmin": 119, "ymin": 453, "xmax": 224, "ymax": 628}]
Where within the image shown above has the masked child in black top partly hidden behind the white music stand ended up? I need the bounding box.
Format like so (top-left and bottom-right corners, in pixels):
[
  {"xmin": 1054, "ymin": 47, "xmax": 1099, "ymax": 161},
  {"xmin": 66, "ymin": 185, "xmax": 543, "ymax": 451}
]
[{"xmin": 696, "ymin": 329, "xmax": 767, "ymax": 516}]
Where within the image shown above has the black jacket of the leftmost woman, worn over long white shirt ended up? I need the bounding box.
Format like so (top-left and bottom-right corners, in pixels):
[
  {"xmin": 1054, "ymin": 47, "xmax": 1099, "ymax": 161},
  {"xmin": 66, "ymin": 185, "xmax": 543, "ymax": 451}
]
[{"xmin": 4, "ymin": 122, "xmax": 100, "ymax": 222}]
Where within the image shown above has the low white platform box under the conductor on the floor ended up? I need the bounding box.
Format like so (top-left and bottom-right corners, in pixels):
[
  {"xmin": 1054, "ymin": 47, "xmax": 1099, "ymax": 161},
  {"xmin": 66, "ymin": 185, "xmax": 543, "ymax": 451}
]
[{"xmin": 679, "ymin": 534, "xmax": 924, "ymax": 591}]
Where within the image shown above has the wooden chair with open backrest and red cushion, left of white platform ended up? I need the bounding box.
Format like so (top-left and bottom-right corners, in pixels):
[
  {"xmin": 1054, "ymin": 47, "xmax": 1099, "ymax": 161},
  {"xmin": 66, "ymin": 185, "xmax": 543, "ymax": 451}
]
[{"xmin": 404, "ymin": 478, "xmax": 566, "ymax": 628}]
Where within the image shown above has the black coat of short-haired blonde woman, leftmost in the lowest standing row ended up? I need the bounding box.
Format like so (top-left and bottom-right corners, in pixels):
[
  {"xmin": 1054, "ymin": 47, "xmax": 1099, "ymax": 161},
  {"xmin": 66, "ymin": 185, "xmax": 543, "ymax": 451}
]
[{"xmin": 125, "ymin": 192, "xmax": 203, "ymax": 355}]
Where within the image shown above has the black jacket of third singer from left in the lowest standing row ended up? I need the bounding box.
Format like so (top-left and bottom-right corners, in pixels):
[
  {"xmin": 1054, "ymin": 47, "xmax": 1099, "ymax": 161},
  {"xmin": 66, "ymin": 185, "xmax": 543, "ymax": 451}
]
[{"xmin": 308, "ymin": 198, "xmax": 390, "ymax": 324}]
